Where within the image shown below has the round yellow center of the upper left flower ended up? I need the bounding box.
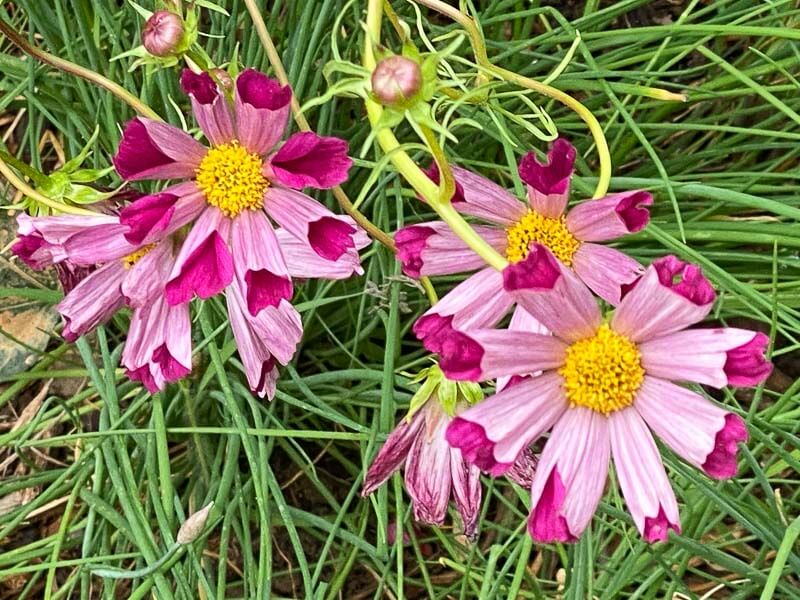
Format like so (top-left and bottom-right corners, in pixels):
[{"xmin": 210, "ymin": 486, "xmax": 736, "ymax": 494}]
[{"xmin": 195, "ymin": 140, "xmax": 269, "ymax": 217}]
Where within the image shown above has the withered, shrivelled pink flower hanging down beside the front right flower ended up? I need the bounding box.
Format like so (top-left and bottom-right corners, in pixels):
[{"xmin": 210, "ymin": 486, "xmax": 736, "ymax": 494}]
[{"xmin": 361, "ymin": 399, "xmax": 481, "ymax": 538}]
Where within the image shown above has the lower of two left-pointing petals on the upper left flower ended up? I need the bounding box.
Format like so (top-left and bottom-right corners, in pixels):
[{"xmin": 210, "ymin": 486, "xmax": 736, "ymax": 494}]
[{"xmin": 119, "ymin": 181, "xmax": 206, "ymax": 244}]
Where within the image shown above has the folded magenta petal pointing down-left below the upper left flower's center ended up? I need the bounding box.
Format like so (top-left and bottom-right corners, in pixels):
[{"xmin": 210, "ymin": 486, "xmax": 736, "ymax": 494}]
[{"xmin": 166, "ymin": 207, "xmax": 233, "ymax": 306}]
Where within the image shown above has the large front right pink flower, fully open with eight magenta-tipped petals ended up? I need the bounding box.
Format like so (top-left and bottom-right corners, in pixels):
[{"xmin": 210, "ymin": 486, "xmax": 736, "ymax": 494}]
[{"xmin": 440, "ymin": 244, "xmax": 772, "ymax": 542}]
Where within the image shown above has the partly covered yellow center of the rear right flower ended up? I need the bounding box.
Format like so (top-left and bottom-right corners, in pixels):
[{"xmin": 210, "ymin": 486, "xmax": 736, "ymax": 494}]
[{"xmin": 506, "ymin": 210, "xmax": 581, "ymax": 267}]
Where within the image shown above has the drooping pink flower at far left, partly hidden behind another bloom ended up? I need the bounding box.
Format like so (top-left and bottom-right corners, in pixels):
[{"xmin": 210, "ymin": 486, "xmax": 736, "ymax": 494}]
[{"xmin": 11, "ymin": 214, "xmax": 192, "ymax": 393}]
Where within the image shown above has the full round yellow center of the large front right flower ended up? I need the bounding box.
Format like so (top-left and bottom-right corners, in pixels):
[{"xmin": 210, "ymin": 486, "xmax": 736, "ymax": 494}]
[{"xmin": 558, "ymin": 324, "xmax": 644, "ymax": 415}]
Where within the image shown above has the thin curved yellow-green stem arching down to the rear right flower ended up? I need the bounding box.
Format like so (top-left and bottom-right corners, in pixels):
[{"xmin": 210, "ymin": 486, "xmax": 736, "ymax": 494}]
[{"xmin": 417, "ymin": 0, "xmax": 611, "ymax": 198}]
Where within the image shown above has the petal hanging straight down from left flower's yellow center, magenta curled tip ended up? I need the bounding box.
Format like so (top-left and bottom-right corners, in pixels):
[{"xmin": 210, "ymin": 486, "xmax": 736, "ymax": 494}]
[{"xmin": 231, "ymin": 210, "xmax": 293, "ymax": 316}]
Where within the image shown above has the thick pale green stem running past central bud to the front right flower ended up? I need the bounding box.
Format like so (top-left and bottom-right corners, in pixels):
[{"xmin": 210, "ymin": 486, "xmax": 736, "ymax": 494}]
[{"xmin": 363, "ymin": 0, "xmax": 508, "ymax": 271}]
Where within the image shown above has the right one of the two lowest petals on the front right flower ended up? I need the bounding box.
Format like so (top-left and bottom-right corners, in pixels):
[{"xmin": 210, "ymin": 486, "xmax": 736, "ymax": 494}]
[{"xmin": 608, "ymin": 407, "xmax": 681, "ymax": 543}]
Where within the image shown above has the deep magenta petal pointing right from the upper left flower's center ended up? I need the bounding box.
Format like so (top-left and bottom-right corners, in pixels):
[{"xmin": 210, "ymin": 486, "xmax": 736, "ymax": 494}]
[{"xmin": 269, "ymin": 131, "xmax": 353, "ymax": 189}]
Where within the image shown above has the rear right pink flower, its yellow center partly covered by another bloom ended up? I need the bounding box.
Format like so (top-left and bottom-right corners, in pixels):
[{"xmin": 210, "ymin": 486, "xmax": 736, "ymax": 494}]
[{"xmin": 395, "ymin": 138, "xmax": 653, "ymax": 352}]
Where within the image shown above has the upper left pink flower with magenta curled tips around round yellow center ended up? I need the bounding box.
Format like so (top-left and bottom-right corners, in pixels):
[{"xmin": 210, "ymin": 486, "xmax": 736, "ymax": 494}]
[{"xmin": 114, "ymin": 69, "xmax": 369, "ymax": 397}]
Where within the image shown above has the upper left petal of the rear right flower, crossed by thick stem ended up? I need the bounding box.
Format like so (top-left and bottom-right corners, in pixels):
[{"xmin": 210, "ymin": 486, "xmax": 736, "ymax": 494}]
[{"xmin": 426, "ymin": 163, "xmax": 527, "ymax": 226}]
